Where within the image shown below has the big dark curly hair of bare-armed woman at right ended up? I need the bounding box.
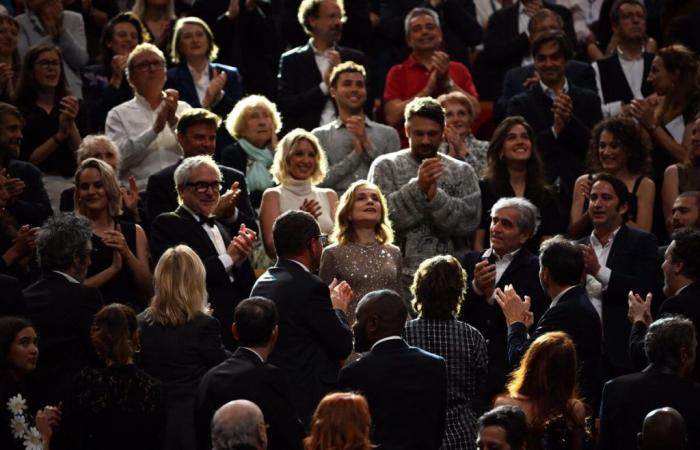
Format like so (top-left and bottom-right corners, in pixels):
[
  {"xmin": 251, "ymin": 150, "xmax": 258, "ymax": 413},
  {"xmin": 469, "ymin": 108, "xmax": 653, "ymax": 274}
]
[{"xmin": 586, "ymin": 116, "xmax": 652, "ymax": 175}]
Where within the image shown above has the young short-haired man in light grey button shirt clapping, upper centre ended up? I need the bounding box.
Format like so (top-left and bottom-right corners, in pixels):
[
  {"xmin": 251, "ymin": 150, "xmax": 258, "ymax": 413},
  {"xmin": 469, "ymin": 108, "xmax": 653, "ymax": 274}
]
[{"xmin": 313, "ymin": 61, "xmax": 401, "ymax": 196}]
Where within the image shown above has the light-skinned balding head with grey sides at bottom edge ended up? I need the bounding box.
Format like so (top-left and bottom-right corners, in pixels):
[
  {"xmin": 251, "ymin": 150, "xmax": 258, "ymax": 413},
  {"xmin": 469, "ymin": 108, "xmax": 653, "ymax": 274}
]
[{"xmin": 211, "ymin": 400, "xmax": 265, "ymax": 450}]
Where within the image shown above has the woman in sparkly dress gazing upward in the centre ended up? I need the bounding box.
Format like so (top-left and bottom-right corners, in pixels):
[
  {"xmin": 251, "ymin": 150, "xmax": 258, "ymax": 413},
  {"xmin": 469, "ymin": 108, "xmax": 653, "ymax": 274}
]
[{"xmin": 320, "ymin": 180, "xmax": 402, "ymax": 323}]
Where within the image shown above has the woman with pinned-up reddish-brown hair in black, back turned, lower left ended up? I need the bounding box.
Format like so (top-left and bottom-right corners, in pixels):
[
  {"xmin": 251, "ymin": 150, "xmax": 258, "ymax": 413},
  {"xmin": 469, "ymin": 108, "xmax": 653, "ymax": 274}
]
[{"xmin": 64, "ymin": 303, "xmax": 165, "ymax": 450}]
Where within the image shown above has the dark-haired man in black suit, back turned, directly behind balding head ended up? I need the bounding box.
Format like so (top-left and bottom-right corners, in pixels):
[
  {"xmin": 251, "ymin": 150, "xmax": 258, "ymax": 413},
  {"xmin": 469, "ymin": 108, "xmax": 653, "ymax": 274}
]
[{"xmin": 195, "ymin": 297, "xmax": 304, "ymax": 450}]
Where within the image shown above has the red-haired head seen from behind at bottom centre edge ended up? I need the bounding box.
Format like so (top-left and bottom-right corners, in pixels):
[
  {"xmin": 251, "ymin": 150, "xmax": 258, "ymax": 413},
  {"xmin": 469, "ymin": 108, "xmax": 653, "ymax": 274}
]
[{"xmin": 304, "ymin": 392, "xmax": 374, "ymax": 450}]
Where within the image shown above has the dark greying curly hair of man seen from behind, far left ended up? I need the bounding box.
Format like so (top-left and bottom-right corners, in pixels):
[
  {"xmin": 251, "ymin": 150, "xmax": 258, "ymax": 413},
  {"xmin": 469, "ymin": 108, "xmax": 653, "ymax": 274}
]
[{"xmin": 36, "ymin": 213, "xmax": 92, "ymax": 271}]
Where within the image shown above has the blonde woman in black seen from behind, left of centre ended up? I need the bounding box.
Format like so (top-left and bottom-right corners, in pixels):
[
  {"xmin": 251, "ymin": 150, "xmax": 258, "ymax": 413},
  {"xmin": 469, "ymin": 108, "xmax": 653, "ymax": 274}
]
[{"xmin": 138, "ymin": 245, "xmax": 226, "ymax": 449}]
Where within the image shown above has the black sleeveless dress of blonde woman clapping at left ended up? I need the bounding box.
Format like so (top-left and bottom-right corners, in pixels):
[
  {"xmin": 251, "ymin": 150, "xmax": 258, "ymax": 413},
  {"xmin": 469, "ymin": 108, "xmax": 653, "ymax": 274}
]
[{"xmin": 87, "ymin": 220, "xmax": 144, "ymax": 312}]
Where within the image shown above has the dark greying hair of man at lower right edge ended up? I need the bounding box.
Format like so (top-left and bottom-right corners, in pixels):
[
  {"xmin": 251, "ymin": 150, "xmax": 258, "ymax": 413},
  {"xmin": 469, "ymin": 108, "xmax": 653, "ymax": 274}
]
[{"xmin": 644, "ymin": 316, "xmax": 695, "ymax": 370}]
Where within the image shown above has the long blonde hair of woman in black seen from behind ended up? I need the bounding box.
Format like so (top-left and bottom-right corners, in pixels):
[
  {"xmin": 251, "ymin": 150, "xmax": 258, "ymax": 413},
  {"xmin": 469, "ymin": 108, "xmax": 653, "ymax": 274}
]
[{"xmin": 146, "ymin": 245, "xmax": 207, "ymax": 325}]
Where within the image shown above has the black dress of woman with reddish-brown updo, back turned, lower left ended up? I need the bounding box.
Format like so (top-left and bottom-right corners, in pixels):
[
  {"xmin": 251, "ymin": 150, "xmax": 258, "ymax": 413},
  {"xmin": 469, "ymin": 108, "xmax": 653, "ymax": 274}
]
[{"xmin": 61, "ymin": 364, "xmax": 165, "ymax": 450}]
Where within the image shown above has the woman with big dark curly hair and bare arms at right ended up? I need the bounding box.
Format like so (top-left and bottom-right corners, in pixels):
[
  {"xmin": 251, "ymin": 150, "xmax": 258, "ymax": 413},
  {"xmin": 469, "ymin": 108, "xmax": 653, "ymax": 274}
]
[{"xmin": 568, "ymin": 116, "xmax": 656, "ymax": 239}]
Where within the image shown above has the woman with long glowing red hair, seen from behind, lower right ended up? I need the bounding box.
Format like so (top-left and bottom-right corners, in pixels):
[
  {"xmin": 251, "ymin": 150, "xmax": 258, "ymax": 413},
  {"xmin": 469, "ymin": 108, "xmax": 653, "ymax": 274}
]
[{"xmin": 494, "ymin": 331, "xmax": 589, "ymax": 450}]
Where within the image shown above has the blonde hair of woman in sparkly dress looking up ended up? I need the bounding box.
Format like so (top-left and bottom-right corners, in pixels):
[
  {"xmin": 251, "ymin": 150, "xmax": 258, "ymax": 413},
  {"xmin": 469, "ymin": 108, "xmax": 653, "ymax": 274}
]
[{"xmin": 331, "ymin": 180, "xmax": 394, "ymax": 245}]
